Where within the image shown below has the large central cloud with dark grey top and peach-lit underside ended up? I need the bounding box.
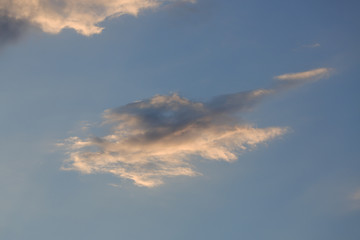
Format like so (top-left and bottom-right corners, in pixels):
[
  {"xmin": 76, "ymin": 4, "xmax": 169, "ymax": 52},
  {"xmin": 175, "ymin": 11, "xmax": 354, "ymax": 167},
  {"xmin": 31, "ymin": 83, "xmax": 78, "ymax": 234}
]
[{"xmin": 61, "ymin": 66, "xmax": 332, "ymax": 187}]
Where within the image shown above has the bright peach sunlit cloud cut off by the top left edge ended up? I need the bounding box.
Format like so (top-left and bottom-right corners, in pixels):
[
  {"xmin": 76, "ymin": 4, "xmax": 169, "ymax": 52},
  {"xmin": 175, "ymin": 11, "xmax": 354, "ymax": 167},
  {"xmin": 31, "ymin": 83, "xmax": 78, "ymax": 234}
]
[{"xmin": 0, "ymin": 0, "xmax": 194, "ymax": 36}]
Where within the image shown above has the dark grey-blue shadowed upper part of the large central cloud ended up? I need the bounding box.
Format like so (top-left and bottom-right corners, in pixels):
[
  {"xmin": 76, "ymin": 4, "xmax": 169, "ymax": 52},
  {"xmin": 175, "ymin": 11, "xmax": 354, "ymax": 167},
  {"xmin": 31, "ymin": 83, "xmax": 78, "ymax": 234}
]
[{"xmin": 105, "ymin": 90, "xmax": 266, "ymax": 143}]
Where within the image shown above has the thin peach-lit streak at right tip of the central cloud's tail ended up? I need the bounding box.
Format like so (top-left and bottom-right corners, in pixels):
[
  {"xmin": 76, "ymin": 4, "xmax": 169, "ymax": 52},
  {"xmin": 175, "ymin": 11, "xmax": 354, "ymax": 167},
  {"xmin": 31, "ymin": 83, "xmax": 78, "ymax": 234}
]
[{"xmin": 274, "ymin": 68, "xmax": 333, "ymax": 80}]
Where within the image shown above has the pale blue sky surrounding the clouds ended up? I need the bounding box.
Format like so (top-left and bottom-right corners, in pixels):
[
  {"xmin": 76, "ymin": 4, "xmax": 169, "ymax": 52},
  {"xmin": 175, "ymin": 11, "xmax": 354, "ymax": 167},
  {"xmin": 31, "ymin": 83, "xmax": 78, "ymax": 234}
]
[{"xmin": 0, "ymin": 0, "xmax": 360, "ymax": 240}]
